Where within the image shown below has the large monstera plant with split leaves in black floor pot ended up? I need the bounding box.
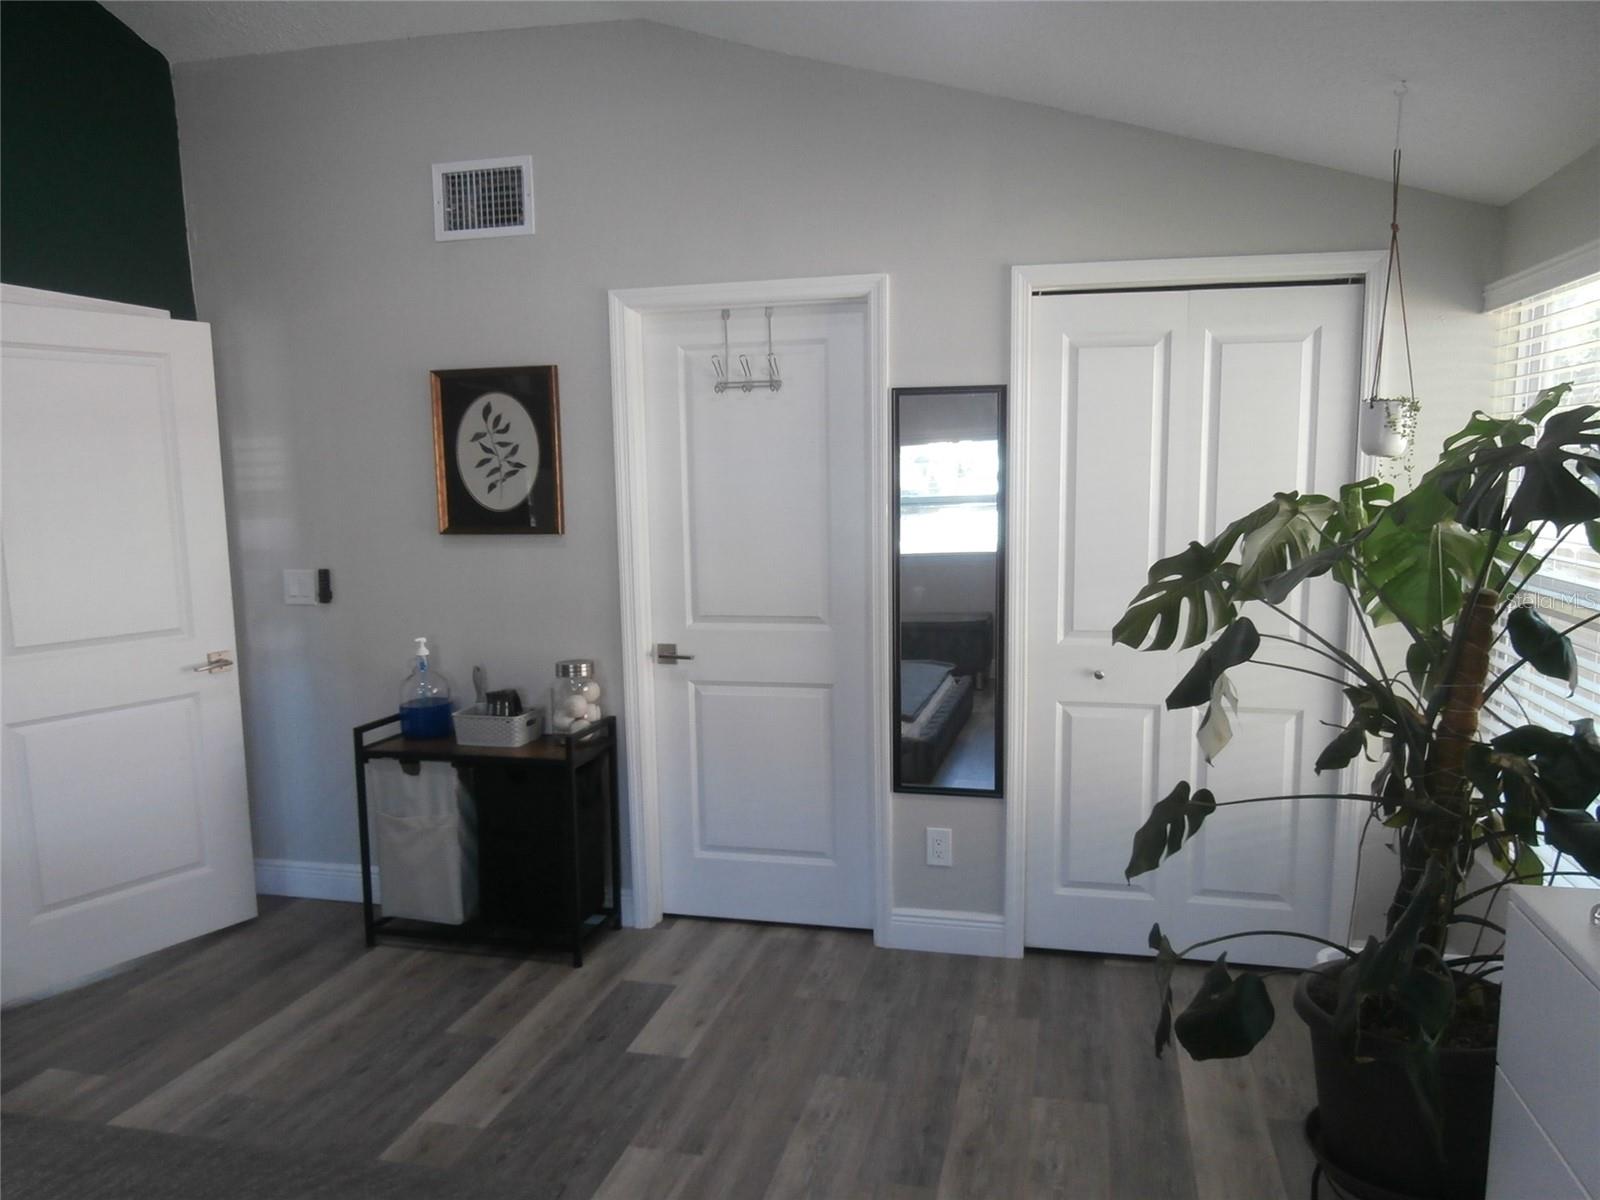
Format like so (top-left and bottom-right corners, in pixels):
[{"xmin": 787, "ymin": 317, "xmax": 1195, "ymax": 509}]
[{"xmin": 1114, "ymin": 384, "xmax": 1600, "ymax": 1195}]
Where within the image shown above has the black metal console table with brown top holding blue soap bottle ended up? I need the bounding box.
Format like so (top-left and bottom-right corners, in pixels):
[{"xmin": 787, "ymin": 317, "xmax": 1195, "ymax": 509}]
[{"xmin": 354, "ymin": 712, "xmax": 622, "ymax": 966}]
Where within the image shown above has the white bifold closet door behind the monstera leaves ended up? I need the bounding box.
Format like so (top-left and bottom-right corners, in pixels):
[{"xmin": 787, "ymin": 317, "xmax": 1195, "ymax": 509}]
[{"xmin": 1022, "ymin": 285, "xmax": 1362, "ymax": 965}]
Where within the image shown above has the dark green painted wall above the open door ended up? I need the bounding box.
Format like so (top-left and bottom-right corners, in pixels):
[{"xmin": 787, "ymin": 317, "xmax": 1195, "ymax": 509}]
[{"xmin": 0, "ymin": 0, "xmax": 195, "ymax": 318}]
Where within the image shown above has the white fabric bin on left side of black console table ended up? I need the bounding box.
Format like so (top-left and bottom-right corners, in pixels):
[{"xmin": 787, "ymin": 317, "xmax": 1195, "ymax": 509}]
[{"xmin": 366, "ymin": 760, "xmax": 478, "ymax": 925}]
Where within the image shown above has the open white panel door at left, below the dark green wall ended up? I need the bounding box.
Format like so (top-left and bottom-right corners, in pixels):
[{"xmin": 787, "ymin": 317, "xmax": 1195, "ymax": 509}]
[{"xmin": 0, "ymin": 304, "xmax": 256, "ymax": 1000}]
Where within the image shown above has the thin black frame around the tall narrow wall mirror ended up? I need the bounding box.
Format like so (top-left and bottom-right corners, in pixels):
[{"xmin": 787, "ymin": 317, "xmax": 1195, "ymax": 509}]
[{"xmin": 890, "ymin": 384, "xmax": 1011, "ymax": 798}]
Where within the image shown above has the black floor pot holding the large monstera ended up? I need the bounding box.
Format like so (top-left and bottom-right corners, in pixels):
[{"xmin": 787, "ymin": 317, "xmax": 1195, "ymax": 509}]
[{"xmin": 1294, "ymin": 963, "xmax": 1494, "ymax": 1200}]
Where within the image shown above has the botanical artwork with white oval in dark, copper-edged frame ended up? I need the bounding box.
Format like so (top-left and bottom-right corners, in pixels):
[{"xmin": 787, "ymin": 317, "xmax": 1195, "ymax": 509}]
[{"xmin": 429, "ymin": 366, "xmax": 562, "ymax": 533}]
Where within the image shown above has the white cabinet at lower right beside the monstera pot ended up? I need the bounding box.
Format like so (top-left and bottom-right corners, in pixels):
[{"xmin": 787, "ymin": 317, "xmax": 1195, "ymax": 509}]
[{"xmin": 1488, "ymin": 886, "xmax": 1600, "ymax": 1200}]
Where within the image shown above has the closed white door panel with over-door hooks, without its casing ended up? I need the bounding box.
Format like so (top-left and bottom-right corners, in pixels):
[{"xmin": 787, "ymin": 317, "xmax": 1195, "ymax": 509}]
[{"xmin": 645, "ymin": 306, "xmax": 872, "ymax": 926}]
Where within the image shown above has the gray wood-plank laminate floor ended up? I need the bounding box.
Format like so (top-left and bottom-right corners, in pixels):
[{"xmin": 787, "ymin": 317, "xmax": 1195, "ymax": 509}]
[{"xmin": 0, "ymin": 898, "xmax": 1314, "ymax": 1200}]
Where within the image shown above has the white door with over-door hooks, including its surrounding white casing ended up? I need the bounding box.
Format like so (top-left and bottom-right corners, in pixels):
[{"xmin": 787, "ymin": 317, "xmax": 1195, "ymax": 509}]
[{"xmin": 611, "ymin": 277, "xmax": 888, "ymax": 928}]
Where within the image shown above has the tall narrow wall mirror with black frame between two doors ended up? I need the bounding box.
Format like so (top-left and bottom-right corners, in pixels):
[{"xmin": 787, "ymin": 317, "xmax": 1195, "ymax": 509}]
[{"xmin": 893, "ymin": 387, "xmax": 1006, "ymax": 795}]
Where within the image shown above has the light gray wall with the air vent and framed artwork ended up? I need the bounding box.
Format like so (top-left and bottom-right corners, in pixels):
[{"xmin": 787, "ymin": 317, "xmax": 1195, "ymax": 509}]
[{"xmin": 176, "ymin": 22, "xmax": 1501, "ymax": 912}]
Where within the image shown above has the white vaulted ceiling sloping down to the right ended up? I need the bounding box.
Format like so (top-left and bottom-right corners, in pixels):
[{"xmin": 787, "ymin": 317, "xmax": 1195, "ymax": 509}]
[{"xmin": 107, "ymin": 0, "xmax": 1600, "ymax": 205}]
